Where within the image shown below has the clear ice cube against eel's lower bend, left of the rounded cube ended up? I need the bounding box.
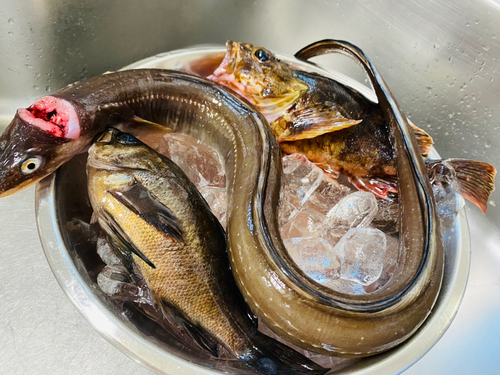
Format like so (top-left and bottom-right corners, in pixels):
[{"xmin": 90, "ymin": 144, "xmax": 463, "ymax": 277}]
[{"xmin": 283, "ymin": 237, "xmax": 340, "ymax": 284}]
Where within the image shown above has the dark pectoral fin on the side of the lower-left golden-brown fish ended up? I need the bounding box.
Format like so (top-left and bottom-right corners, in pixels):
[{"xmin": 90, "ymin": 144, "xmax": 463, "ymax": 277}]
[{"xmin": 108, "ymin": 180, "xmax": 184, "ymax": 242}]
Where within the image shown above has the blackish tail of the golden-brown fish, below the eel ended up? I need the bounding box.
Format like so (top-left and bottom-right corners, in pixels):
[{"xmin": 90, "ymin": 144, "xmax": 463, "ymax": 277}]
[{"xmin": 242, "ymin": 331, "xmax": 328, "ymax": 375}]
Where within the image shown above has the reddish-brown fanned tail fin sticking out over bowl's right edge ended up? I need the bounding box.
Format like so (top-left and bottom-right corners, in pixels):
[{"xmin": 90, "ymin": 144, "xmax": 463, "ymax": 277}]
[{"xmin": 444, "ymin": 159, "xmax": 497, "ymax": 213}]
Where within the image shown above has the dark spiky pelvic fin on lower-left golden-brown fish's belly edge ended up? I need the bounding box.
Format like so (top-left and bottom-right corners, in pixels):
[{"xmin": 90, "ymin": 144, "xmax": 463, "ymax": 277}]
[{"xmin": 99, "ymin": 210, "xmax": 156, "ymax": 270}]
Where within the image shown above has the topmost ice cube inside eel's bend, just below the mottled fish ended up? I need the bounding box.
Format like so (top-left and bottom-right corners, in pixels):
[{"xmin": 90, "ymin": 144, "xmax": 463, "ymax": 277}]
[{"xmin": 283, "ymin": 154, "xmax": 323, "ymax": 209}]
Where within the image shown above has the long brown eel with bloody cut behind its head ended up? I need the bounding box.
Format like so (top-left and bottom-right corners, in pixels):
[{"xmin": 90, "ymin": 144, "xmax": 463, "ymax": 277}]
[{"xmin": 0, "ymin": 42, "xmax": 443, "ymax": 356}]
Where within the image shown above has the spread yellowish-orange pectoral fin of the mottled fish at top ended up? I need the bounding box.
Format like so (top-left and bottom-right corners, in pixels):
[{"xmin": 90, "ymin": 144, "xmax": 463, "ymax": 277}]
[{"xmin": 277, "ymin": 102, "xmax": 362, "ymax": 142}]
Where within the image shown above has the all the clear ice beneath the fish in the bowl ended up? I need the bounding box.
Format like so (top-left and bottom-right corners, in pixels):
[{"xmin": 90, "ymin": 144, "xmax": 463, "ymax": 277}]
[{"xmin": 97, "ymin": 130, "xmax": 463, "ymax": 300}]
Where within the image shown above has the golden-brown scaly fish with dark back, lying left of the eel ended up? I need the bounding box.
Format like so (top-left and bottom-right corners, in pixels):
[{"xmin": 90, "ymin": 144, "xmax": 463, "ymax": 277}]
[{"xmin": 87, "ymin": 130, "xmax": 326, "ymax": 374}]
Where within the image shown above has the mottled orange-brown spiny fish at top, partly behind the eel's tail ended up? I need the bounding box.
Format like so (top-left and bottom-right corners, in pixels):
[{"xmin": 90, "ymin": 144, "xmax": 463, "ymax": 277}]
[{"xmin": 209, "ymin": 41, "xmax": 496, "ymax": 212}]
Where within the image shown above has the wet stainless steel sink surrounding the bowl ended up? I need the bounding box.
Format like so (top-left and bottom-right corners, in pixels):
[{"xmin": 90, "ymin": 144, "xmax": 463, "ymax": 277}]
[{"xmin": 0, "ymin": 0, "xmax": 500, "ymax": 374}]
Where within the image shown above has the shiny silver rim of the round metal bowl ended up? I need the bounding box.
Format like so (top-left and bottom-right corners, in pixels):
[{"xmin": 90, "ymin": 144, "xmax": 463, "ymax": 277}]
[{"xmin": 35, "ymin": 45, "xmax": 470, "ymax": 375}]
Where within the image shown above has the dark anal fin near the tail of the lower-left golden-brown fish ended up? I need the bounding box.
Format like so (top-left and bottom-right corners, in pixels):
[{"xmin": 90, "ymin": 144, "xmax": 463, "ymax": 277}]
[{"xmin": 159, "ymin": 300, "xmax": 219, "ymax": 357}]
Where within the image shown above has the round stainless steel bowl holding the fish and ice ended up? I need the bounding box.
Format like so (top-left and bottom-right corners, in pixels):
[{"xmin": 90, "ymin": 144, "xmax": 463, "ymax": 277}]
[{"xmin": 36, "ymin": 47, "xmax": 470, "ymax": 375}]
